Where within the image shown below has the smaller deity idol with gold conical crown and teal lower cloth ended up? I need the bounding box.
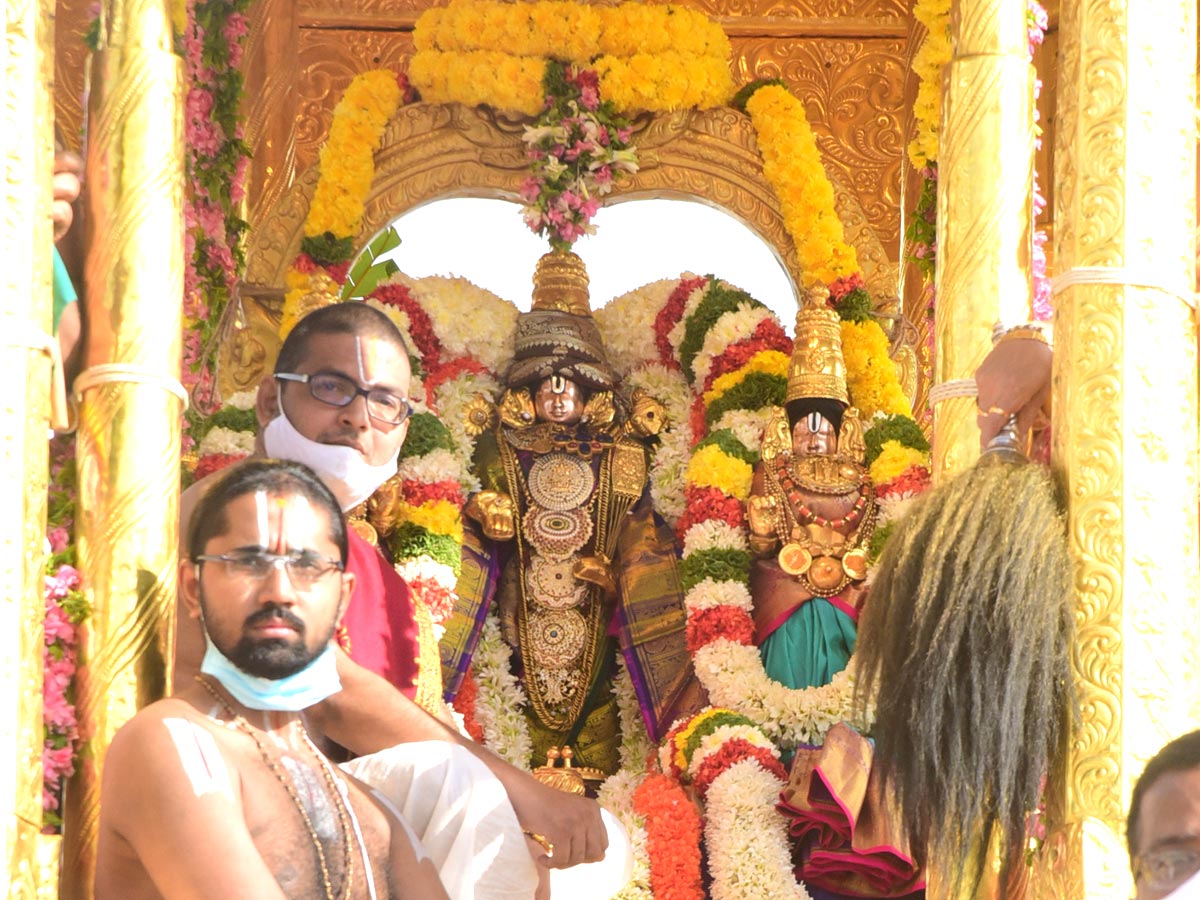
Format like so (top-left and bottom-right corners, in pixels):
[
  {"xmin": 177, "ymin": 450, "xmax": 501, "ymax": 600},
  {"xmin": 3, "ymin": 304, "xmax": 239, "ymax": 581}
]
[{"xmin": 748, "ymin": 290, "xmax": 876, "ymax": 688}]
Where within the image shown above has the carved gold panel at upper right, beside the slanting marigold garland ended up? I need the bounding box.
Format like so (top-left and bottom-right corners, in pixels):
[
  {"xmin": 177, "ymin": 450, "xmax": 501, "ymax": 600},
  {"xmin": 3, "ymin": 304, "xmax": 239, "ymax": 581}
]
[{"xmin": 733, "ymin": 38, "xmax": 907, "ymax": 259}]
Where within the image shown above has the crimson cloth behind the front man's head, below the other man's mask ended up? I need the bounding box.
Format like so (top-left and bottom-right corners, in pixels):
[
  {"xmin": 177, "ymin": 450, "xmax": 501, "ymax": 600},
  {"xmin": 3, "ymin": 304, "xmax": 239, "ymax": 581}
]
[{"xmin": 342, "ymin": 529, "xmax": 418, "ymax": 698}]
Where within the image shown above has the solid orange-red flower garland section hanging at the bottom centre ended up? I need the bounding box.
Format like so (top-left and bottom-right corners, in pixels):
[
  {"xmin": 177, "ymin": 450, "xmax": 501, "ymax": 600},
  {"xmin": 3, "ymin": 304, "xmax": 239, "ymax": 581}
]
[{"xmin": 634, "ymin": 774, "xmax": 704, "ymax": 900}]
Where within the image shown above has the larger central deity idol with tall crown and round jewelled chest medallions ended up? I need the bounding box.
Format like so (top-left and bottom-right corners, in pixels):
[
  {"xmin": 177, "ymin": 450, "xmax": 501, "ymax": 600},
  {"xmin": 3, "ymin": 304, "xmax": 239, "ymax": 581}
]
[{"xmin": 442, "ymin": 252, "xmax": 700, "ymax": 774}]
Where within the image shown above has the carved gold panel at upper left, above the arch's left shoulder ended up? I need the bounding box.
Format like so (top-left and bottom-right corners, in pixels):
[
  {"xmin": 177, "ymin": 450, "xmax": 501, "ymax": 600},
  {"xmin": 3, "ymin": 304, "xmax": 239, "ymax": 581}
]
[{"xmin": 292, "ymin": 29, "xmax": 413, "ymax": 172}]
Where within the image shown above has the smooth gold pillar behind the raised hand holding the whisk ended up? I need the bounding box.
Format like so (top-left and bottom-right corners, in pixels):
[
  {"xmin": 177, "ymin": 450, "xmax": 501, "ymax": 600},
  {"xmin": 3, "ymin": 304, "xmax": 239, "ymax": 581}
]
[{"xmin": 934, "ymin": 0, "xmax": 1034, "ymax": 480}]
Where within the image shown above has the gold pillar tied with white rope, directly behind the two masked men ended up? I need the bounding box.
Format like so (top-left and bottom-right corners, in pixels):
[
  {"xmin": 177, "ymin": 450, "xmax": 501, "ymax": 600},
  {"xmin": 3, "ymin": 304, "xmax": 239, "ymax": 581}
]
[{"xmin": 64, "ymin": 0, "xmax": 184, "ymax": 900}]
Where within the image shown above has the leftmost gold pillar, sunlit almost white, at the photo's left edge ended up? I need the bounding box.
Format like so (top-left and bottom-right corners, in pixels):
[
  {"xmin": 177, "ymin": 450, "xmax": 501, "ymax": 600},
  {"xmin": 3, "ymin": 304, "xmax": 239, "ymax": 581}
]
[{"xmin": 0, "ymin": 0, "xmax": 54, "ymax": 898}]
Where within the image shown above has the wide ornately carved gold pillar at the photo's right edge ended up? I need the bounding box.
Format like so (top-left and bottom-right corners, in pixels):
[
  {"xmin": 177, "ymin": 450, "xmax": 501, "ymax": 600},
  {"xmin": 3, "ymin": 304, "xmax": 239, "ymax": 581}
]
[{"xmin": 1034, "ymin": 0, "xmax": 1200, "ymax": 899}]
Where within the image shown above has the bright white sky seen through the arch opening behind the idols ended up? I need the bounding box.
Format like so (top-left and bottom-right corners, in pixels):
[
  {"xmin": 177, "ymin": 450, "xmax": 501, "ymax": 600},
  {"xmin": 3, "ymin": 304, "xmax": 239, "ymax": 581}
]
[{"xmin": 379, "ymin": 198, "xmax": 797, "ymax": 334}]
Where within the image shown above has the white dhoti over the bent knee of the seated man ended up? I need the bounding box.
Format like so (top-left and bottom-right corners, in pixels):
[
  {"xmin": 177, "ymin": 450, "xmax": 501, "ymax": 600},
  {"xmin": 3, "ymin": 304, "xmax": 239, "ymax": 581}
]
[{"xmin": 342, "ymin": 740, "xmax": 538, "ymax": 900}]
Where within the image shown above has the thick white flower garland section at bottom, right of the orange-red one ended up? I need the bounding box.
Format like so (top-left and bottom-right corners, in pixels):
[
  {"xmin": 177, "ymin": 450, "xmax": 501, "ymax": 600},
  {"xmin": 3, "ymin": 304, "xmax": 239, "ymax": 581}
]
[{"xmin": 704, "ymin": 760, "xmax": 809, "ymax": 900}]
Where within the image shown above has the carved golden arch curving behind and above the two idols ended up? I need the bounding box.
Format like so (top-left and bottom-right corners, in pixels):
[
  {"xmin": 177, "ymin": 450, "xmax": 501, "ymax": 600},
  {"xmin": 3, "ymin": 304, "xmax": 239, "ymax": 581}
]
[{"xmin": 236, "ymin": 103, "xmax": 917, "ymax": 396}]
